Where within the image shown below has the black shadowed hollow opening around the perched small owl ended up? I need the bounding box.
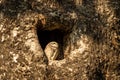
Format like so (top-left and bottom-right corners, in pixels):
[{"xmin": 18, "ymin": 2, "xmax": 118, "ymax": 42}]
[{"xmin": 37, "ymin": 29, "xmax": 64, "ymax": 60}]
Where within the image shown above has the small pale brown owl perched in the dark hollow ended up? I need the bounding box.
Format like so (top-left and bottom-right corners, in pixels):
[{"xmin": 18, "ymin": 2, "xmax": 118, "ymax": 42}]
[{"xmin": 44, "ymin": 41, "xmax": 59, "ymax": 61}]
